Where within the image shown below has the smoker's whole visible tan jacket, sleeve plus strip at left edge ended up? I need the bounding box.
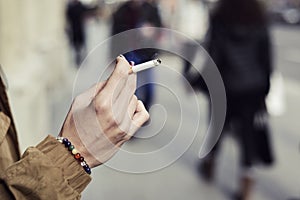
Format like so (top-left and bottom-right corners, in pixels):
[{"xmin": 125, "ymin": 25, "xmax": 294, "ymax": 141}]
[{"xmin": 0, "ymin": 77, "xmax": 91, "ymax": 200}]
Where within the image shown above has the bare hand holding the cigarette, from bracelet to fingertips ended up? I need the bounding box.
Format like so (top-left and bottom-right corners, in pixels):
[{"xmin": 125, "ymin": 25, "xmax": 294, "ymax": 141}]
[{"xmin": 60, "ymin": 56, "xmax": 149, "ymax": 167}]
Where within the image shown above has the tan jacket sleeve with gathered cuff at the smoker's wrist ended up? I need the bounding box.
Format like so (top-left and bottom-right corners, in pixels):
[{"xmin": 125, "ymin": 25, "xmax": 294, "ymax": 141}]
[{"xmin": 0, "ymin": 136, "xmax": 91, "ymax": 200}]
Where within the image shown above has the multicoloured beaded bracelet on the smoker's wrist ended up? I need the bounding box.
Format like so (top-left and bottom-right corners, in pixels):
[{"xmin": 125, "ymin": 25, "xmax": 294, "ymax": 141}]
[{"xmin": 56, "ymin": 137, "xmax": 92, "ymax": 174}]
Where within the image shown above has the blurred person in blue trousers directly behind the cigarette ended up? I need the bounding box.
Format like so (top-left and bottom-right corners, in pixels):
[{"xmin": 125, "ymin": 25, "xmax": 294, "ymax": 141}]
[{"xmin": 111, "ymin": 0, "xmax": 162, "ymax": 110}]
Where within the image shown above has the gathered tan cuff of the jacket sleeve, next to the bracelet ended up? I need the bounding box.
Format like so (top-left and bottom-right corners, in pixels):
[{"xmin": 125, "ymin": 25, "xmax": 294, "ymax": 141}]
[{"xmin": 36, "ymin": 135, "xmax": 91, "ymax": 193}]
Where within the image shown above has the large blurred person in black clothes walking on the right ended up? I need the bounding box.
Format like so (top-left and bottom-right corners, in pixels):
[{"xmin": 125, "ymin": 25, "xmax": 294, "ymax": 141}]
[{"xmin": 200, "ymin": 0, "xmax": 273, "ymax": 200}]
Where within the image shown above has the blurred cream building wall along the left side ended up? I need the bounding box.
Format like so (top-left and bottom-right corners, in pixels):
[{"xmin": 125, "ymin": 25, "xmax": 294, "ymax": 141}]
[{"xmin": 0, "ymin": 0, "xmax": 69, "ymax": 150}]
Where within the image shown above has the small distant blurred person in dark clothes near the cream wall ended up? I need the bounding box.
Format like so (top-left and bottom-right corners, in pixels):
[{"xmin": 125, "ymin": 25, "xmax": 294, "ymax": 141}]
[{"xmin": 66, "ymin": 0, "xmax": 97, "ymax": 66}]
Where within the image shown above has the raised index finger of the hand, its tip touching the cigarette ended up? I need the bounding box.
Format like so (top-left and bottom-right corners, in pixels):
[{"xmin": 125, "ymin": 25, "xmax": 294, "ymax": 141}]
[{"xmin": 102, "ymin": 55, "xmax": 130, "ymax": 97}]
